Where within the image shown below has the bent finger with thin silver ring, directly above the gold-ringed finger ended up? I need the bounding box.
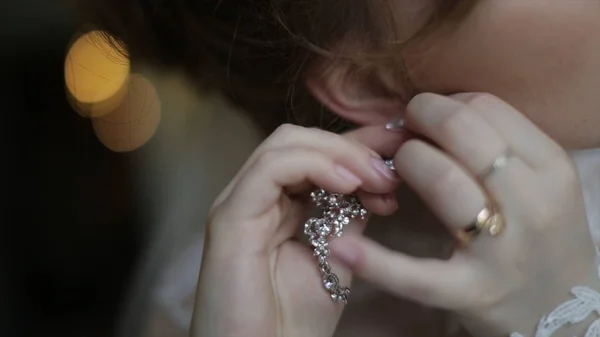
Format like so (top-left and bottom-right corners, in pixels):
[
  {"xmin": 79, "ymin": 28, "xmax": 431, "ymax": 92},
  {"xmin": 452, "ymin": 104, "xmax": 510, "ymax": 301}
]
[{"xmin": 406, "ymin": 94, "xmax": 508, "ymax": 176}]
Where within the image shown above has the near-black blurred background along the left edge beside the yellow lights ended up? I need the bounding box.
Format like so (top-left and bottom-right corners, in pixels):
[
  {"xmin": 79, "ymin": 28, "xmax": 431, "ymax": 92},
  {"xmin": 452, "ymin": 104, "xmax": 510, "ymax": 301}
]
[{"xmin": 0, "ymin": 0, "xmax": 145, "ymax": 336}]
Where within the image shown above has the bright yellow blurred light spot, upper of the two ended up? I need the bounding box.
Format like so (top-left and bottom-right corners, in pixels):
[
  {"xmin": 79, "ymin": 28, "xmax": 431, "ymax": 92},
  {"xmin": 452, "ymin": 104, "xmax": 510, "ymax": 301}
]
[{"xmin": 65, "ymin": 31, "xmax": 130, "ymax": 117}]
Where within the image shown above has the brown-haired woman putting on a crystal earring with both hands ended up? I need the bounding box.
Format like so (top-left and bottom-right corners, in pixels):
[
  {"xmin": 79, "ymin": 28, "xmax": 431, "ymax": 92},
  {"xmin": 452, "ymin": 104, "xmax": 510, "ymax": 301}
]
[{"xmin": 79, "ymin": 0, "xmax": 600, "ymax": 336}]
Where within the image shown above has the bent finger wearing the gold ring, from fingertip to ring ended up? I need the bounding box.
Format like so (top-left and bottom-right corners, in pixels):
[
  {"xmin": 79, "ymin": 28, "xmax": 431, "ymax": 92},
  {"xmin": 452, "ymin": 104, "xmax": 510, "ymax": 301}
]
[{"xmin": 394, "ymin": 140, "xmax": 486, "ymax": 231}]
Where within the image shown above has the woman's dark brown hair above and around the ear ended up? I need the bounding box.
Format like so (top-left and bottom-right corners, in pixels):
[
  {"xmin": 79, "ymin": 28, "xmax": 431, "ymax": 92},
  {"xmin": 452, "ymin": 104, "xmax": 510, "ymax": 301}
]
[{"xmin": 78, "ymin": 0, "xmax": 476, "ymax": 132}]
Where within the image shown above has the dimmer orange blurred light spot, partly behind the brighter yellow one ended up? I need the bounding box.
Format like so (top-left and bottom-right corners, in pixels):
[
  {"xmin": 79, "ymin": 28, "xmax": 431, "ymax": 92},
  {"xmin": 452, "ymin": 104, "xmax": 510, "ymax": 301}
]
[{"xmin": 92, "ymin": 74, "xmax": 161, "ymax": 152}]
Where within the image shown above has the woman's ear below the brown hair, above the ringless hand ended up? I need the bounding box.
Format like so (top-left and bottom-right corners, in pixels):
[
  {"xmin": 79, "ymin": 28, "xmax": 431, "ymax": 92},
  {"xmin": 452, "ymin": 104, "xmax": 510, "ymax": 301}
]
[{"xmin": 306, "ymin": 62, "xmax": 405, "ymax": 125}]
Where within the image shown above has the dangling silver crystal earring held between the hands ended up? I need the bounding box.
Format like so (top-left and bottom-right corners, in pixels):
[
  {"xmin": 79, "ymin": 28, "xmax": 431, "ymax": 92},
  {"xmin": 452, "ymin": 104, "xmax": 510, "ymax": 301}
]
[{"xmin": 304, "ymin": 189, "xmax": 368, "ymax": 304}]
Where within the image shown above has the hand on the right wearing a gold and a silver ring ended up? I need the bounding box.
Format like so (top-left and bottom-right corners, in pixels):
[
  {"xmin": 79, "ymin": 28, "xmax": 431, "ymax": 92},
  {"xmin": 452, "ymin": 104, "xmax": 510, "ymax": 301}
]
[{"xmin": 332, "ymin": 94, "xmax": 598, "ymax": 337}]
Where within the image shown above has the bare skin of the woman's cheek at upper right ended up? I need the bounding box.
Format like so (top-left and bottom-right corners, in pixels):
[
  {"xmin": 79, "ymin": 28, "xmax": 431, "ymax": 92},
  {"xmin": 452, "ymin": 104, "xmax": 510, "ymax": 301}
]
[{"xmin": 405, "ymin": 0, "xmax": 600, "ymax": 148}]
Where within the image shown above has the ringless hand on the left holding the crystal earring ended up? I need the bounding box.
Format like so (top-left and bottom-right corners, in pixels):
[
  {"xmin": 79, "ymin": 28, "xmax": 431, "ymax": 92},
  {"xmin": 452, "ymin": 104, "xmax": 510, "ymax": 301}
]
[{"xmin": 192, "ymin": 125, "xmax": 402, "ymax": 337}]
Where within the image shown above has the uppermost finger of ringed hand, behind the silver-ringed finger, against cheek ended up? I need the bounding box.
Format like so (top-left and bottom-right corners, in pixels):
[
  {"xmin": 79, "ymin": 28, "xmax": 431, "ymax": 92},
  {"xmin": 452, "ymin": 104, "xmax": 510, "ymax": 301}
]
[{"xmin": 450, "ymin": 93, "xmax": 564, "ymax": 168}]
